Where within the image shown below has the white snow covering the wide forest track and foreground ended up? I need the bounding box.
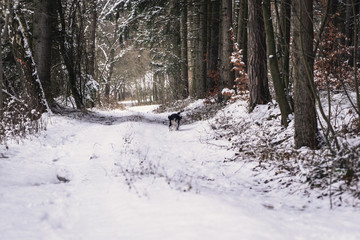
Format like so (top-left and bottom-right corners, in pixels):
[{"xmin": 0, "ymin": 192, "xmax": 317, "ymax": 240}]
[{"xmin": 0, "ymin": 103, "xmax": 360, "ymax": 240}]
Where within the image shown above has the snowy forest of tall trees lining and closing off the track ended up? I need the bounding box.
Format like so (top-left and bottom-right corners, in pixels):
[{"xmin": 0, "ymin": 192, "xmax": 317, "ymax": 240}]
[{"xmin": 0, "ymin": 0, "xmax": 360, "ymax": 200}]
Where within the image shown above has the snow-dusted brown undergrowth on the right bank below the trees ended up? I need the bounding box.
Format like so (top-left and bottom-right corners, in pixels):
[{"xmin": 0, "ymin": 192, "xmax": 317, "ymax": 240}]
[{"xmin": 211, "ymin": 98, "xmax": 360, "ymax": 207}]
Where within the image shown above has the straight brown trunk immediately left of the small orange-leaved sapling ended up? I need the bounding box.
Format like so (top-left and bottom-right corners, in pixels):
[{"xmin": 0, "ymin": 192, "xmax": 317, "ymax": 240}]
[{"xmin": 219, "ymin": 0, "xmax": 235, "ymax": 100}]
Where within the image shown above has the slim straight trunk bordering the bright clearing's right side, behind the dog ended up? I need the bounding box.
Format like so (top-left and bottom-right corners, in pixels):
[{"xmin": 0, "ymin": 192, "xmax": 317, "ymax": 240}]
[{"xmin": 180, "ymin": 2, "xmax": 189, "ymax": 98}]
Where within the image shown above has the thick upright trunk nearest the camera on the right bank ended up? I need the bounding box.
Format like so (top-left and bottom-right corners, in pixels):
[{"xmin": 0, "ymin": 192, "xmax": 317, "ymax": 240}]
[{"xmin": 291, "ymin": 0, "xmax": 317, "ymax": 149}]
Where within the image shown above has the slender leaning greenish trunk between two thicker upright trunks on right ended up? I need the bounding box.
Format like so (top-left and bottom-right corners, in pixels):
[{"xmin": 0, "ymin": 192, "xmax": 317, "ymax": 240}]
[{"xmin": 262, "ymin": 0, "xmax": 291, "ymax": 127}]
